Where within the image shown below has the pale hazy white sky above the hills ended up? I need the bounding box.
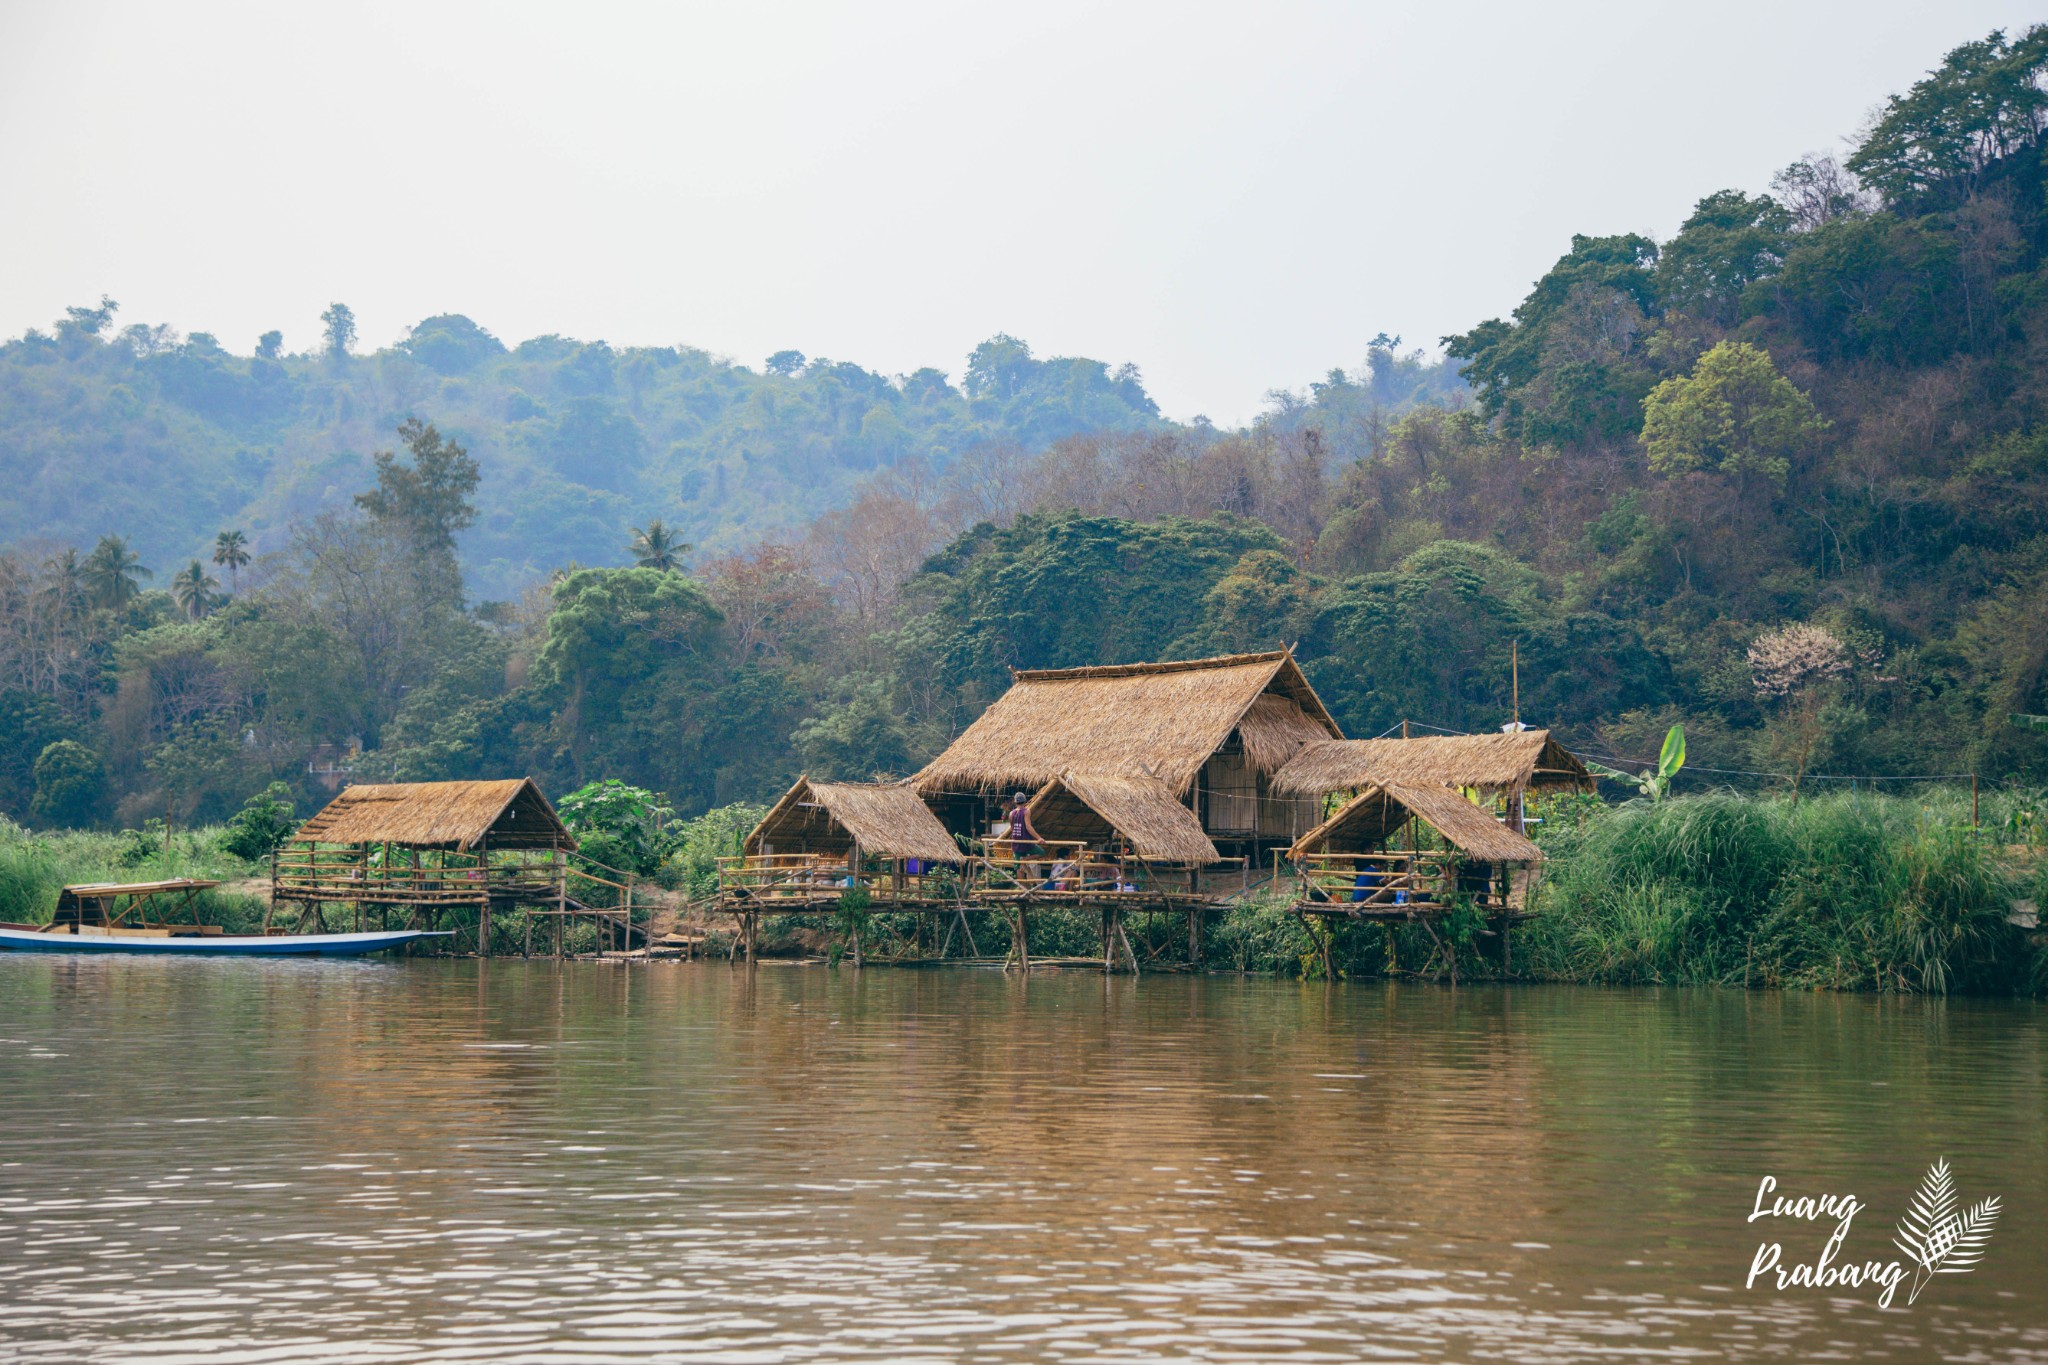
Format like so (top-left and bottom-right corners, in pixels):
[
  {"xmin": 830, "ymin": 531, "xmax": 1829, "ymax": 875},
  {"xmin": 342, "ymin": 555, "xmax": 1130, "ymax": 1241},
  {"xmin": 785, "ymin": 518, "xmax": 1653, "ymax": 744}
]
[{"xmin": 0, "ymin": 0, "xmax": 2040, "ymax": 424}]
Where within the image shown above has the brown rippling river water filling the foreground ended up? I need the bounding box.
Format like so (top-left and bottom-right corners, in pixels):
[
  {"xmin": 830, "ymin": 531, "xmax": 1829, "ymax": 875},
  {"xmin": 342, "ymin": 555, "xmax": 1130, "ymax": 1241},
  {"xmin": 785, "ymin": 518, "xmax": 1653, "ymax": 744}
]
[{"xmin": 0, "ymin": 956, "xmax": 2048, "ymax": 1365}]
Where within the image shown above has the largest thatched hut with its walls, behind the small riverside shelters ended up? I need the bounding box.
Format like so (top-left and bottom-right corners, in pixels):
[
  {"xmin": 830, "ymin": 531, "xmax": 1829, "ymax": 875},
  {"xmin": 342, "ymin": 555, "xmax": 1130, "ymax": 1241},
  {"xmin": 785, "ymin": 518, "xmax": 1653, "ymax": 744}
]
[{"xmin": 911, "ymin": 651, "xmax": 1343, "ymax": 843}]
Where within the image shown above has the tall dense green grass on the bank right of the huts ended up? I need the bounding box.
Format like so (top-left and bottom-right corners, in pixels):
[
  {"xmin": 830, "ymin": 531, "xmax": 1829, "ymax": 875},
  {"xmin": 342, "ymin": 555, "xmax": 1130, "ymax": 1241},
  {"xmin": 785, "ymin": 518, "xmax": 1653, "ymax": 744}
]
[{"xmin": 1516, "ymin": 792, "xmax": 2042, "ymax": 995}]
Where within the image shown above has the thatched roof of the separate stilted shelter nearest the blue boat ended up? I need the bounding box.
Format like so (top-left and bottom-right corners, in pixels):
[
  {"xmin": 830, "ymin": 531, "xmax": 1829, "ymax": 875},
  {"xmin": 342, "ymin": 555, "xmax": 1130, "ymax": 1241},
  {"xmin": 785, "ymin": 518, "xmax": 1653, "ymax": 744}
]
[{"xmin": 293, "ymin": 778, "xmax": 575, "ymax": 849}]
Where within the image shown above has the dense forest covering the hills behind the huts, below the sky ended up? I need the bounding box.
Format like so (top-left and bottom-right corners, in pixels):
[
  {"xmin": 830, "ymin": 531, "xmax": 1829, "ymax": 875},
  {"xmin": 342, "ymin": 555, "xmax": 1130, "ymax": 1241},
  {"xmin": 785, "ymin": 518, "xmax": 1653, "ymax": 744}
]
[{"xmin": 0, "ymin": 29, "xmax": 2048, "ymax": 827}]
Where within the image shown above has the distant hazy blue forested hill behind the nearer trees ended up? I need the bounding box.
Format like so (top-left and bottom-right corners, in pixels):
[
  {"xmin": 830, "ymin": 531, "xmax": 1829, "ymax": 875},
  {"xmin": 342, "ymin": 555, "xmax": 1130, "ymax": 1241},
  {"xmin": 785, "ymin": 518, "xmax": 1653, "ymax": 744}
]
[{"xmin": 0, "ymin": 315, "xmax": 1458, "ymax": 598}]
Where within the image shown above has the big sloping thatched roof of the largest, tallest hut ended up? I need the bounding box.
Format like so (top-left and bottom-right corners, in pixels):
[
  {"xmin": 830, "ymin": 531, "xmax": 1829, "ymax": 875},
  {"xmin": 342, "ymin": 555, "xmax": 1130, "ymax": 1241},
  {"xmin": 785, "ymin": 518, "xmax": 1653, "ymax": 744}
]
[{"xmin": 911, "ymin": 651, "xmax": 1343, "ymax": 796}]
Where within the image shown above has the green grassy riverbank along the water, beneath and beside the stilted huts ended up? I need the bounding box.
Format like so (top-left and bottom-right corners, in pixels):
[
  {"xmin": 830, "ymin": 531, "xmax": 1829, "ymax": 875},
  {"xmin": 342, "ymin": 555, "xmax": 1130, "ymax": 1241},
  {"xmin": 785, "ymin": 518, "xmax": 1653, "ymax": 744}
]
[{"xmin": 0, "ymin": 790, "xmax": 2048, "ymax": 997}]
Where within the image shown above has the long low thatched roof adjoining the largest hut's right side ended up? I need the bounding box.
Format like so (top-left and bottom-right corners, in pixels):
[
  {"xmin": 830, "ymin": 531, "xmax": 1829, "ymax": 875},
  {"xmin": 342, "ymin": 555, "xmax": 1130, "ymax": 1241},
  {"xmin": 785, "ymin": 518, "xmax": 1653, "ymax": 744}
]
[{"xmin": 1274, "ymin": 731, "xmax": 1593, "ymax": 796}]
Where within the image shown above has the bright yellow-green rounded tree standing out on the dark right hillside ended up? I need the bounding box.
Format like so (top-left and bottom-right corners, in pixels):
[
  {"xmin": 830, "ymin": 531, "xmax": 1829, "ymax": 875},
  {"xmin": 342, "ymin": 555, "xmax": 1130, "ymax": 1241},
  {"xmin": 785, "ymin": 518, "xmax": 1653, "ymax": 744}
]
[{"xmin": 1642, "ymin": 342, "xmax": 1827, "ymax": 487}]
